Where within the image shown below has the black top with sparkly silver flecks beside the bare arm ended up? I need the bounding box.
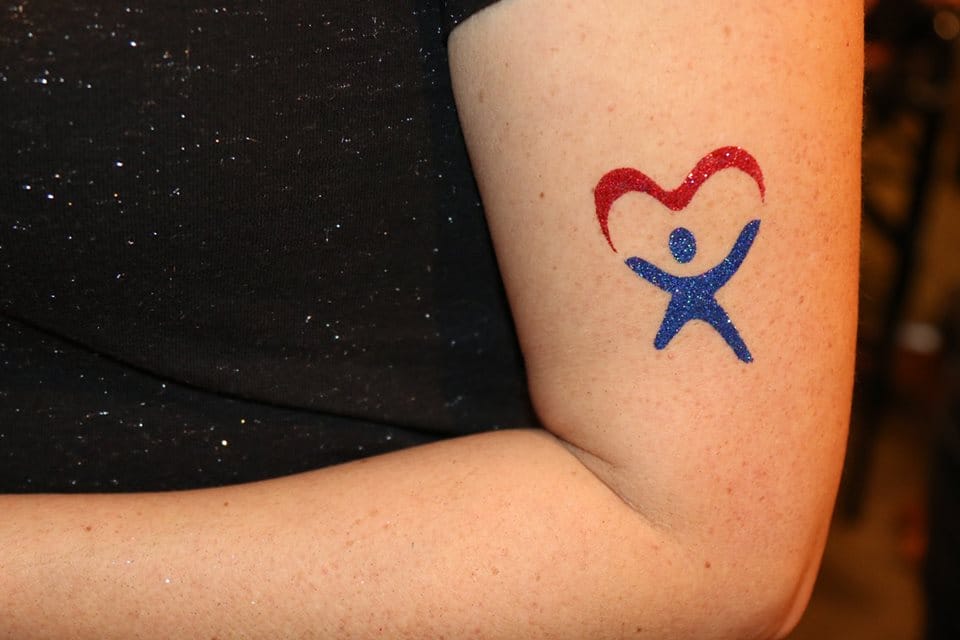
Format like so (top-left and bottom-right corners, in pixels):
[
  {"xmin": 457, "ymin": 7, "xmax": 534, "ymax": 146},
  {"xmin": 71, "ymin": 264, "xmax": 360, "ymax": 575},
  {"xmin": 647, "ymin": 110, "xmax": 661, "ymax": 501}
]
[{"xmin": 0, "ymin": 0, "xmax": 535, "ymax": 491}]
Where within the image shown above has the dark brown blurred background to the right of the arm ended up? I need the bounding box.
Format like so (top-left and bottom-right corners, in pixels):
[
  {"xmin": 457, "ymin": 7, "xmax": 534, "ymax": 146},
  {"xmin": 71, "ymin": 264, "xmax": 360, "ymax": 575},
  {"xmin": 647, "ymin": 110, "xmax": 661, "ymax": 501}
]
[{"xmin": 790, "ymin": 0, "xmax": 960, "ymax": 640}]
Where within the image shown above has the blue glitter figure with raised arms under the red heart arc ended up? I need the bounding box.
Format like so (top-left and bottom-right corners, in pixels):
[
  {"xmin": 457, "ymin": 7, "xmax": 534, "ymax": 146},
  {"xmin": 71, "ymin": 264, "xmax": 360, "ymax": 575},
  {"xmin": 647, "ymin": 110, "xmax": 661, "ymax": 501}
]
[{"xmin": 627, "ymin": 220, "xmax": 760, "ymax": 362}]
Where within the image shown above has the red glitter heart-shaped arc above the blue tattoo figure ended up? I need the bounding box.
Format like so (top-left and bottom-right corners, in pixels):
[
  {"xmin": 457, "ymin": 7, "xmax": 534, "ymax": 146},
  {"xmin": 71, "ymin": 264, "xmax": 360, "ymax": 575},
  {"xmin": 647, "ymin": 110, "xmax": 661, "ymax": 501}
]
[{"xmin": 593, "ymin": 147, "xmax": 766, "ymax": 253}]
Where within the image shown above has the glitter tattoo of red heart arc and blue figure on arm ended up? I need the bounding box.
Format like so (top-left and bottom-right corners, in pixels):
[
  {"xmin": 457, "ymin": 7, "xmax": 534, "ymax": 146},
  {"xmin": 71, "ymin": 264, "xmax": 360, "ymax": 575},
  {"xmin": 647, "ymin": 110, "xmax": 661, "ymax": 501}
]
[{"xmin": 594, "ymin": 147, "xmax": 765, "ymax": 362}]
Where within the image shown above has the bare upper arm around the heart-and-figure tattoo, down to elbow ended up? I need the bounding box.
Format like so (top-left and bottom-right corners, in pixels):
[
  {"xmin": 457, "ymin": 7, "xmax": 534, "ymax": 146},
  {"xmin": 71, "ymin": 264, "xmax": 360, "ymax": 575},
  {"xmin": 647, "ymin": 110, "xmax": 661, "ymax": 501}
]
[{"xmin": 450, "ymin": 0, "xmax": 862, "ymax": 632}]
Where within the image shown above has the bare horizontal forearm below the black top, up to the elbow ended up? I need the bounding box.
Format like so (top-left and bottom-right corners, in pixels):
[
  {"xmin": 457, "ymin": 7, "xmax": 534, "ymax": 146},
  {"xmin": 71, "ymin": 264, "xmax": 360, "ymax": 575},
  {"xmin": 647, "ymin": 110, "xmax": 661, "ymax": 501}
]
[{"xmin": 0, "ymin": 431, "xmax": 743, "ymax": 640}]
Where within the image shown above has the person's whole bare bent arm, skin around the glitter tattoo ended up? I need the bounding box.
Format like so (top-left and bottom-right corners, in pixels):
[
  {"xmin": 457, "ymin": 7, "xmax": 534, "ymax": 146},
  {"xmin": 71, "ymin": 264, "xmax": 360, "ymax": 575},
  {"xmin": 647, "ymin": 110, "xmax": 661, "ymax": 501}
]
[{"xmin": 0, "ymin": 0, "xmax": 862, "ymax": 640}]
